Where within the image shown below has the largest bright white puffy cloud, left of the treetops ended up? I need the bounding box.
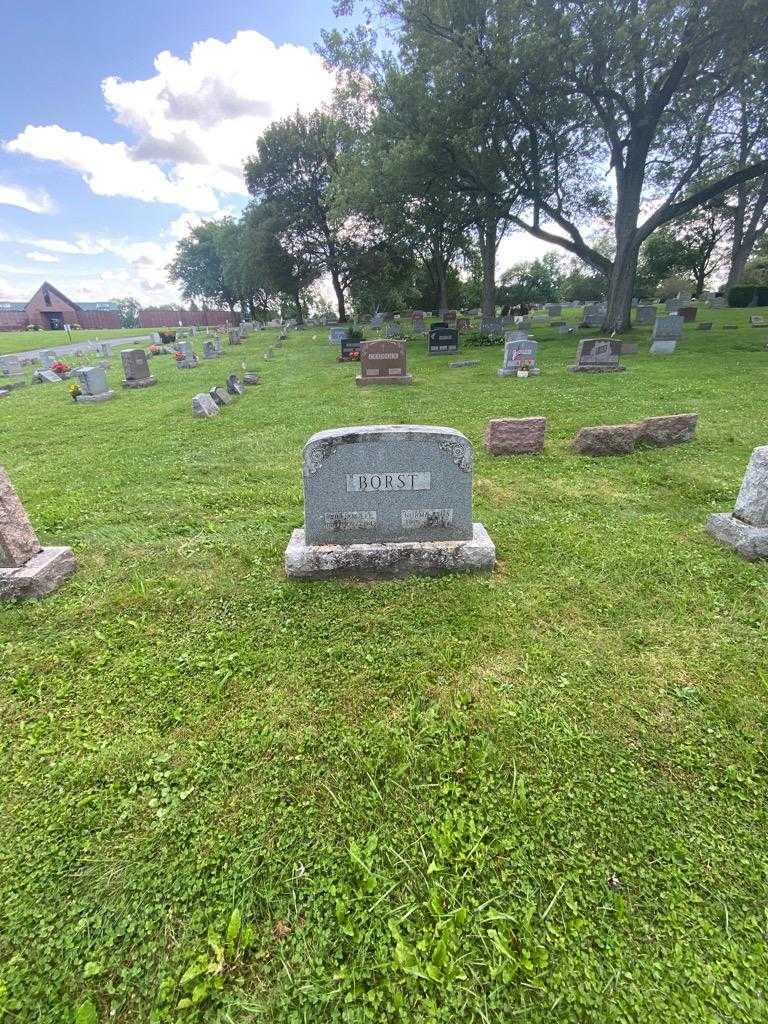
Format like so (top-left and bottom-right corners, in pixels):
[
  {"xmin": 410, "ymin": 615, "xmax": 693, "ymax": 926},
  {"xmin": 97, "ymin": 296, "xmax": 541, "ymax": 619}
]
[{"xmin": 0, "ymin": 32, "xmax": 334, "ymax": 216}]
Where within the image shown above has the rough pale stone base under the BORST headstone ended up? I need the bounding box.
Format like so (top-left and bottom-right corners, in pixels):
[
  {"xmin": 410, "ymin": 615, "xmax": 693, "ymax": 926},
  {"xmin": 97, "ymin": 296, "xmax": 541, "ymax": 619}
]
[{"xmin": 285, "ymin": 522, "xmax": 496, "ymax": 580}]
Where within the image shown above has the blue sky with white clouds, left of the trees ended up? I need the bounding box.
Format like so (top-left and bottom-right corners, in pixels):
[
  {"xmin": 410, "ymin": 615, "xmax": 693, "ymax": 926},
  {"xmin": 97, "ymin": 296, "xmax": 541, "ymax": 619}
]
[{"xmin": 0, "ymin": 0, "xmax": 346, "ymax": 304}]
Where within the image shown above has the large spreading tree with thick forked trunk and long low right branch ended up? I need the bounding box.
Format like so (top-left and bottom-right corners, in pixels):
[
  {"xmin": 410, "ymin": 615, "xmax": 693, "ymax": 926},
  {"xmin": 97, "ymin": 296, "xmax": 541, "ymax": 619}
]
[{"xmin": 337, "ymin": 0, "xmax": 768, "ymax": 331}]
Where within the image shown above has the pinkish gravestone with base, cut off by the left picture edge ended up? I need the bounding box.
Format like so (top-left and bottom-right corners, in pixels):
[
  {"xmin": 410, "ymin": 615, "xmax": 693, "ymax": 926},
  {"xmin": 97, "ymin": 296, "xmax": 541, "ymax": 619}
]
[{"xmin": 0, "ymin": 466, "xmax": 77, "ymax": 601}]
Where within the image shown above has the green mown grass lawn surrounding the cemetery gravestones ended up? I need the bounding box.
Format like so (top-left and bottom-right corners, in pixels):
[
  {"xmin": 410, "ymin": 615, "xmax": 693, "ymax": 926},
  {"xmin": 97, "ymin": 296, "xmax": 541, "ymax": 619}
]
[{"xmin": 0, "ymin": 310, "xmax": 768, "ymax": 1024}]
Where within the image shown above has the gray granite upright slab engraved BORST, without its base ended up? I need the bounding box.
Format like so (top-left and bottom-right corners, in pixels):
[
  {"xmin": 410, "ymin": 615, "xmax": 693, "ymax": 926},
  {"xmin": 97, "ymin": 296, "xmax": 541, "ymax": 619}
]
[{"xmin": 303, "ymin": 426, "xmax": 473, "ymax": 545}]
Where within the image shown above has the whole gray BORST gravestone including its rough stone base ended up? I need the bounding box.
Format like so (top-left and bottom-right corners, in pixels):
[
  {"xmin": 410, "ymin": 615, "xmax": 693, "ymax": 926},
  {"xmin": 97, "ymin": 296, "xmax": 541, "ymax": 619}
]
[{"xmin": 285, "ymin": 425, "xmax": 496, "ymax": 580}]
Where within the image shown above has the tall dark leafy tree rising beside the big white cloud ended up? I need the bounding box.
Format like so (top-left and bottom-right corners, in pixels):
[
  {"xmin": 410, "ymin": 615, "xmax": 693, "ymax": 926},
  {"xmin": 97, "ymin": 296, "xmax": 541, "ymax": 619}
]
[{"xmin": 245, "ymin": 113, "xmax": 381, "ymax": 322}]
